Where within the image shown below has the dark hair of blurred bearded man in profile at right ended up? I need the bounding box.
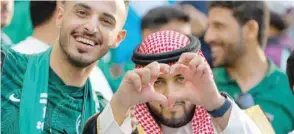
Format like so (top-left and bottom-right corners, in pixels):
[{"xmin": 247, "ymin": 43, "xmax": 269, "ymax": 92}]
[{"xmin": 208, "ymin": 1, "xmax": 269, "ymax": 48}]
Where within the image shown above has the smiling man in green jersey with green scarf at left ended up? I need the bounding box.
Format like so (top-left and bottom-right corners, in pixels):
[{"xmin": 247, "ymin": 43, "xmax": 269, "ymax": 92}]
[{"xmin": 1, "ymin": 0, "xmax": 128, "ymax": 134}]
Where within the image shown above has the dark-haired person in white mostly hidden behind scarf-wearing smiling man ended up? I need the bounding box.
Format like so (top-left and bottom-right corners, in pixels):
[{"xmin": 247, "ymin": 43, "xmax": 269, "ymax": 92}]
[{"xmin": 12, "ymin": 1, "xmax": 113, "ymax": 100}]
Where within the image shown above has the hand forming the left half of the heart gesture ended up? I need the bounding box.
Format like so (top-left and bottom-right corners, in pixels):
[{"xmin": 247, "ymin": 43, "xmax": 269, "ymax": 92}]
[{"xmin": 110, "ymin": 62, "xmax": 169, "ymax": 125}]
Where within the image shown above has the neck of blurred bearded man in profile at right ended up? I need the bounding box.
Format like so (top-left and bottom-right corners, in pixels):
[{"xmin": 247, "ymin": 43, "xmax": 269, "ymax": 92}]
[{"xmin": 227, "ymin": 48, "xmax": 269, "ymax": 93}]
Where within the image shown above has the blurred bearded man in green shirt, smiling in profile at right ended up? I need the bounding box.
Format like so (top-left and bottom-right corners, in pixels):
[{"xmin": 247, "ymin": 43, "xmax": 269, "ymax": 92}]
[{"xmin": 205, "ymin": 1, "xmax": 294, "ymax": 134}]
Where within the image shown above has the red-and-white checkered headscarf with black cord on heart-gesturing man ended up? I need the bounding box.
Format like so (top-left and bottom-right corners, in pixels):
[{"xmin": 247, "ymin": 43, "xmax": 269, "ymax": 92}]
[{"xmin": 132, "ymin": 31, "xmax": 214, "ymax": 134}]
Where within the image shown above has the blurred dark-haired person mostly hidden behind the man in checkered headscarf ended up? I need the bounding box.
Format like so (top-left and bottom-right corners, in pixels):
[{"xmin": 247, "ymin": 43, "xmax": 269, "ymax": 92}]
[{"xmin": 141, "ymin": 5, "xmax": 211, "ymax": 65}]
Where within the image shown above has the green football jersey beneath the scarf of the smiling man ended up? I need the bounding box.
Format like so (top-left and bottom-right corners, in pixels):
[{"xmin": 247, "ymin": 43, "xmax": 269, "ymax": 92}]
[{"xmin": 1, "ymin": 46, "xmax": 107, "ymax": 134}]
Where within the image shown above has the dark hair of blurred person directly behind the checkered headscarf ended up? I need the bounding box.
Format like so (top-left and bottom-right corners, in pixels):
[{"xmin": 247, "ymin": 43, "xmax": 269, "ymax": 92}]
[{"xmin": 141, "ymin": 6, "xmax": 190, "ymax": 30}]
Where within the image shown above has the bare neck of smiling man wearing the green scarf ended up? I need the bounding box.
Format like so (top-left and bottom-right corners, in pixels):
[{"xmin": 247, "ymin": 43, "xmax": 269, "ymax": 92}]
[{"xmin": 50, "ymin": 44, "xmax": 95, "ymax": 87}]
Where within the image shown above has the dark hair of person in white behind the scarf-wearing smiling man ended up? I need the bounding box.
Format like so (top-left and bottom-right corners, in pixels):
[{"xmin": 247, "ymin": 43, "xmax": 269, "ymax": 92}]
[{"xmin": 30, "ymin": 1, "xmax": 56, "ymax": 28}]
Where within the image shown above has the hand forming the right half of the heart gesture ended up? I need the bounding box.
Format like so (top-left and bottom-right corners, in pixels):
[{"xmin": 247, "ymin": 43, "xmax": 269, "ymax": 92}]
[{"xmin": 168, "ymin": 53, "xmax": 225, "ymax": 111}]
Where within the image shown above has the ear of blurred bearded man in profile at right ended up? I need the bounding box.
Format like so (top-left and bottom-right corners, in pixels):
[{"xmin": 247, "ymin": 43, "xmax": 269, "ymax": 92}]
[{"xmin": 244, "ymin": 20, "xmax": 259, "ymax": 41}]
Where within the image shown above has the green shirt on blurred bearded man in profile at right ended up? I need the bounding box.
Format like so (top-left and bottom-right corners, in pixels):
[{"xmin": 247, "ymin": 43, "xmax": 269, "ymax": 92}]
[{"xmin": 213, "ymin": 61, "xmax": 294, "ymax": 134}]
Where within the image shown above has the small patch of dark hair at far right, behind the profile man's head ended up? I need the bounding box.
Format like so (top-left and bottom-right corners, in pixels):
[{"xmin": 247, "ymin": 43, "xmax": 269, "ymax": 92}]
[{"xmin": 270, "ymin": 12, "xmax": 287, "ymax": 31}]
